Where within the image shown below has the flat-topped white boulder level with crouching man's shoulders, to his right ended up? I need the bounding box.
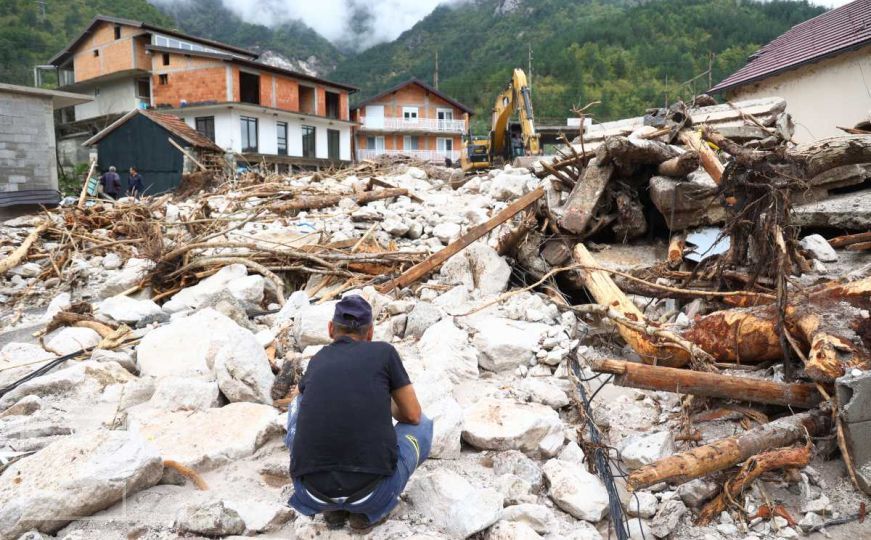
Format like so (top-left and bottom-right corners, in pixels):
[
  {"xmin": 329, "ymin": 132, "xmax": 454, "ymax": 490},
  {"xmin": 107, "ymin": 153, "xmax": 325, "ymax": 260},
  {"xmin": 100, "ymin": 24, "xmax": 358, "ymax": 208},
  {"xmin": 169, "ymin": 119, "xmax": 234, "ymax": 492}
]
[{"xmin": 471, "ymin": 317, "xmax": 548, "ymax": 371}]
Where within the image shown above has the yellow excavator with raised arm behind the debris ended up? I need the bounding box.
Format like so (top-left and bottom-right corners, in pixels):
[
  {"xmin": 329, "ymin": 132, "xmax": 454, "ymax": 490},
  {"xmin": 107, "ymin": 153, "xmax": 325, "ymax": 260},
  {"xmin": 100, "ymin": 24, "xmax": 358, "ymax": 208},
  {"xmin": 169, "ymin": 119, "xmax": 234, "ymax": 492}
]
[{"xmin": 460, "ymin": 69, "xmax": 541, "ymax": 172}]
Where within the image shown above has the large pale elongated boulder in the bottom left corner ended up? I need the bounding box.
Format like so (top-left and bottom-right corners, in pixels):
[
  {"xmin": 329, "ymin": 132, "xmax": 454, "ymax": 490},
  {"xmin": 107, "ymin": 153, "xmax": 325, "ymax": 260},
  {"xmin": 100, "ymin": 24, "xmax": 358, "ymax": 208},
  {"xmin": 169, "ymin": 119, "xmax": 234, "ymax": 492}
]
[{"xmin": 0, "ymin": 430, "xmax": 163, "ymax": 538}]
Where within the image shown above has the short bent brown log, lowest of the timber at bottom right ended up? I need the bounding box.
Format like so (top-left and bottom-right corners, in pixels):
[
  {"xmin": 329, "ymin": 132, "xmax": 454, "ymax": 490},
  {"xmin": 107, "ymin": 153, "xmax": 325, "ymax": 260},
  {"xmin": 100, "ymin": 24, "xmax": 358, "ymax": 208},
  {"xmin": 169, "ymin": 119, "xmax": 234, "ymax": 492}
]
[{"xmin": 696, "ymin": 445, "xmax": 811, "ymax": 525}]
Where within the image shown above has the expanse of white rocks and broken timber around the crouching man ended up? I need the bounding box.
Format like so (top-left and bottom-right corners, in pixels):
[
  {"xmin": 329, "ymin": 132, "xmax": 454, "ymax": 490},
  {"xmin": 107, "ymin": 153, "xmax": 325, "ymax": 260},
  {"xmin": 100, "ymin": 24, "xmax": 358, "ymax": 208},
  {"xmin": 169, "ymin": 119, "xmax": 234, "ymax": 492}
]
[{"xmin": 0, "ymin": 99, "xmax": 871, "ymax": 540}]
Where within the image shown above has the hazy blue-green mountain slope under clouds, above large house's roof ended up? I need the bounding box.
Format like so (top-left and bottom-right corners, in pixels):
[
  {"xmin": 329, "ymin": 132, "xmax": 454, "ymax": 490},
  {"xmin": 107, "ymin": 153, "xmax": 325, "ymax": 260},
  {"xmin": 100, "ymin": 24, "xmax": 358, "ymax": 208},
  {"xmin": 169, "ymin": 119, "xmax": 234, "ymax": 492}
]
[{"xmin": 154, "ymin": 0, "xmax": 345, "ymax": 75}]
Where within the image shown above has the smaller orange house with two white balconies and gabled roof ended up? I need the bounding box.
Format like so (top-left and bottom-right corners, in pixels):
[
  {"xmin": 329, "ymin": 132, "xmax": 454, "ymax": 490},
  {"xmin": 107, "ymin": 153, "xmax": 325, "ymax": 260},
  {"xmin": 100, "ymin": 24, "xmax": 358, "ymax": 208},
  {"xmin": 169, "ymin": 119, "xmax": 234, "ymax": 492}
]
[{"xmin": 351, "ymin": 79, "xmax": 473, "ymax": 162}]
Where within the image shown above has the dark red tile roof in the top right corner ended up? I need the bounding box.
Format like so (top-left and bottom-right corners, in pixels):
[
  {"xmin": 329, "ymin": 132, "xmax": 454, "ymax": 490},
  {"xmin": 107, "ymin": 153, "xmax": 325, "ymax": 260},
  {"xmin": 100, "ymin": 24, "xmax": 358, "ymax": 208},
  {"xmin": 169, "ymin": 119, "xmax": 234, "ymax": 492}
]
[{"xmin": 710, "ymin": 0, "xmax": 871, "ymax": 92}]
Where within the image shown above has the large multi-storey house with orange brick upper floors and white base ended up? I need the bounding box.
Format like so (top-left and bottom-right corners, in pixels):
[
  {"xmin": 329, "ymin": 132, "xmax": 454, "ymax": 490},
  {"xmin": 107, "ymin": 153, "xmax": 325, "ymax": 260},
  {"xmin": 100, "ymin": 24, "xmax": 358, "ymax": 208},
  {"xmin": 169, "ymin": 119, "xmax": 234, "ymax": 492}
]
[{"xmin": 40, "ymin": 16, "xmax": 357, "ymax": 166}]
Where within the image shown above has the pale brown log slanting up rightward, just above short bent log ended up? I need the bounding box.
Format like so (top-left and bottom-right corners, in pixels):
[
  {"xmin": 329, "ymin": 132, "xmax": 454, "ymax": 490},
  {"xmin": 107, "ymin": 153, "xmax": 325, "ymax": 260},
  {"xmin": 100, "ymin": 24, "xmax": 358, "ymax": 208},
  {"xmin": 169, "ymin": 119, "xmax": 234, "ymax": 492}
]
[{"xmin": 627, "ymin": 407, "xmax": 832, "ymax": 490}]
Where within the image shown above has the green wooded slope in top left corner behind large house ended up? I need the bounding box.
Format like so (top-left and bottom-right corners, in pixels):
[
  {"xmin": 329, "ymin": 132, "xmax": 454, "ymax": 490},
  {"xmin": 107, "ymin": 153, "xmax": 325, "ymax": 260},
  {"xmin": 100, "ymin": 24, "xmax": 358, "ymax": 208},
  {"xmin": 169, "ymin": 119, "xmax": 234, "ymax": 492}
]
[{"xmin": 0, "ymin": 0, "xmax": 172, "ymax": 85}]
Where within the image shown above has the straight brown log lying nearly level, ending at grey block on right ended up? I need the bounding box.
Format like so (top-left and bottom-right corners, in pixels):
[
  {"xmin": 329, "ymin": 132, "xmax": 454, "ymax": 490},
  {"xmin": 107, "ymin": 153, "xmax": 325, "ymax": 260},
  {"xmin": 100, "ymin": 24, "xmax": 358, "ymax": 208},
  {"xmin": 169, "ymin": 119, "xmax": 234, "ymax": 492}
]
[{"xmin": 591, "ymin": 359, "xmax": 823, "ymax": 409}]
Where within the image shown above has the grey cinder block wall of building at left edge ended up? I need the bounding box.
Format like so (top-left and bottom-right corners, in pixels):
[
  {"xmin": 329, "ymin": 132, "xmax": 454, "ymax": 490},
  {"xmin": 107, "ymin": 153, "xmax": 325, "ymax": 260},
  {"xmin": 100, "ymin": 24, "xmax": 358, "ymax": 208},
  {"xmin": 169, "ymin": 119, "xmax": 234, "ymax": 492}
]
[{"xmin": 0, "ymin": 92, "xmax": 58, "ymax": 191}]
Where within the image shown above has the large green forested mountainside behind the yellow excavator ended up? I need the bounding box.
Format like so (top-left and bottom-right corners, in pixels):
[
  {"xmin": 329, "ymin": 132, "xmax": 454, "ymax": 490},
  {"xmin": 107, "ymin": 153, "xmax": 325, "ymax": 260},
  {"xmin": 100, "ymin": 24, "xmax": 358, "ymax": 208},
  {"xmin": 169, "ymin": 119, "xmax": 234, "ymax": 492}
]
[{"xmin": 330, "ymin": 0, "xmax": 823, "ymax": 130}]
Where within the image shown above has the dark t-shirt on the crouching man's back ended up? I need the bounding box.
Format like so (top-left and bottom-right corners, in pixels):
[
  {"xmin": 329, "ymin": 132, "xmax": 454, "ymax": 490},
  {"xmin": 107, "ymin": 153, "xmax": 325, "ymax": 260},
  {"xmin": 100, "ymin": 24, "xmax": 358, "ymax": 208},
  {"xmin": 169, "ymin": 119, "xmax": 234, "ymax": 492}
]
[{"xmin": 290, "ymin": 336, "xmax": 411, "ymax": 497}]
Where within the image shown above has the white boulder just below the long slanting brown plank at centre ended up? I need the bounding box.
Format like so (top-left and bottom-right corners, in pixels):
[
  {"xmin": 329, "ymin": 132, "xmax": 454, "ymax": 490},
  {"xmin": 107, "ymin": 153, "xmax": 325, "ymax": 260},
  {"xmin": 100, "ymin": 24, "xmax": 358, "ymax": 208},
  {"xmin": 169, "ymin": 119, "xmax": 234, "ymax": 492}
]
[{"xmin": 441, "ymin": 242, "xmax": 511, "ymax": 295}]
